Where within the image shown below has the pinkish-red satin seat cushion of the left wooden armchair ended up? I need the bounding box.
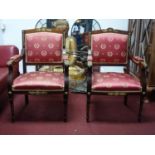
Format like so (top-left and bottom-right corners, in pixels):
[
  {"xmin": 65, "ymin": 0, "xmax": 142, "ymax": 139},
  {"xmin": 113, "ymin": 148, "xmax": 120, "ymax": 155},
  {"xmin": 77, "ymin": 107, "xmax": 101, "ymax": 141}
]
[{"xmin": 12, "ymin": 71, "xmax": 64, "ymax": 91}]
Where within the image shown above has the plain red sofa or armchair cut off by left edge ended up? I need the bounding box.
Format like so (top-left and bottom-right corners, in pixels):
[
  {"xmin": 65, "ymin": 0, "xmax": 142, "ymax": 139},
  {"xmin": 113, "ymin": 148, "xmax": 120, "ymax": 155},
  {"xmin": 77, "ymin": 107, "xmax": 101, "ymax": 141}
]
[{"xmin": 0, "ymin": 45, "xmax": 19, "ymax": 93}]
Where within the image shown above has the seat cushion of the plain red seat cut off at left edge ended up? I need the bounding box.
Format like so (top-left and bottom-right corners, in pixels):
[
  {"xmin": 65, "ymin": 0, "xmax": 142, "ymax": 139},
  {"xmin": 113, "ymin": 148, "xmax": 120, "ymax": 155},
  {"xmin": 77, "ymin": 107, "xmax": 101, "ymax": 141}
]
[{"xmin": 0, "ymin": 67, "xmax": 8, "ymax": 92}]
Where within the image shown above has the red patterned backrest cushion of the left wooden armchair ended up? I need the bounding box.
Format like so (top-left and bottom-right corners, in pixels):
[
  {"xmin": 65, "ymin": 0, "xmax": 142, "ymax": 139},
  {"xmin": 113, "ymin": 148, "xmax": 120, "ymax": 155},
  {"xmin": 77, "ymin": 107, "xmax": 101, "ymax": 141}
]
[{"xmin": 25, "ymin": 32, "xmax": 63, "ymax": 63}]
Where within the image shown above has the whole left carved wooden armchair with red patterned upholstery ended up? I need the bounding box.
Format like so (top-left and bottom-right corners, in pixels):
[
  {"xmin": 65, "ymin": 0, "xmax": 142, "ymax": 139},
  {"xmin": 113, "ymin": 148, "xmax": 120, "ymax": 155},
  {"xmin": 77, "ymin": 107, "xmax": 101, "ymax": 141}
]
[{"xmin": 8, "ymin": 29, "xmax": 68, "ymax": 121}]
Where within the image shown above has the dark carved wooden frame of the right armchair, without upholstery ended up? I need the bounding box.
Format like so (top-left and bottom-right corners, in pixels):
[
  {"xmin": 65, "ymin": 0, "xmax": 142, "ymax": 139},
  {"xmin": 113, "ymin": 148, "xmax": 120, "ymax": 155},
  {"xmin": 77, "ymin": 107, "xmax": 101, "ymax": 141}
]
[{"xmin": 86, "ymin": 28, "xmax": 147, "ymax": 122}]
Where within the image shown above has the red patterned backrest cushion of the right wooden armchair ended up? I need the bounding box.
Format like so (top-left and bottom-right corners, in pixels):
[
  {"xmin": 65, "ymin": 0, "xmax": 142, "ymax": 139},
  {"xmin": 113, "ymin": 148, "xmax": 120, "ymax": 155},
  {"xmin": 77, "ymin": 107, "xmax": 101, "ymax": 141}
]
[{"xmin": 91, "ymin": 32, "xmax": 128, "ymax": 64}]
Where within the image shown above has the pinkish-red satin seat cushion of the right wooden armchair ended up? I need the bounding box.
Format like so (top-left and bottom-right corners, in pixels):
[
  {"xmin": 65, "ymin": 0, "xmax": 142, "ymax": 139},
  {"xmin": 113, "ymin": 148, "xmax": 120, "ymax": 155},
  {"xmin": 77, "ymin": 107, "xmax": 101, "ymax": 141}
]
[{"xmin": 92, "ymin": 72, "xmax": 142, "ymax": 91}]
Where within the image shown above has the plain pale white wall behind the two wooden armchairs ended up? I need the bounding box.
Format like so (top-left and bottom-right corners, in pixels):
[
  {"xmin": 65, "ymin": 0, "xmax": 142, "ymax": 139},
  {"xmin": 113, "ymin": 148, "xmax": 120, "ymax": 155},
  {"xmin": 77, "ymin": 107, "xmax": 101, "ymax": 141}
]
[{"xmin": 0, "ymin": 19, "xmax": 128, "ymax": 72}]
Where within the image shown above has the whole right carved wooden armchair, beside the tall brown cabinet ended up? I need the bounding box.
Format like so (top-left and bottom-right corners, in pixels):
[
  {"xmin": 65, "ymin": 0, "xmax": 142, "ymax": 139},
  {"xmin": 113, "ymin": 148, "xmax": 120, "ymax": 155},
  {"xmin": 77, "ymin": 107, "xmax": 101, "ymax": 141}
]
[{"xmin": 86, "ymin": 28, "xmax": 146, "ymax": 122}]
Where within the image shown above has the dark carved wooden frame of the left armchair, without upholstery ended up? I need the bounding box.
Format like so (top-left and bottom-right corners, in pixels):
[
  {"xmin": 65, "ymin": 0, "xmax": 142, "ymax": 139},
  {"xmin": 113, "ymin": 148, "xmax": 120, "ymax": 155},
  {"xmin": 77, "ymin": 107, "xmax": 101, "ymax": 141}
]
[{"xmin": 7, "ymin": 28, "xmax": 69, "ymax": 122}]
